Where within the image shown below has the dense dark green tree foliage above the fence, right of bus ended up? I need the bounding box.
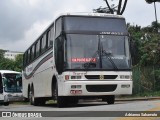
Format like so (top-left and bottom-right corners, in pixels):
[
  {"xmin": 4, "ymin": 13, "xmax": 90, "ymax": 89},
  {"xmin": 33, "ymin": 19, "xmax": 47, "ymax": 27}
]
[{"xmin": 127, "ymin": 22, "xmax": 160, "ymax": 66}]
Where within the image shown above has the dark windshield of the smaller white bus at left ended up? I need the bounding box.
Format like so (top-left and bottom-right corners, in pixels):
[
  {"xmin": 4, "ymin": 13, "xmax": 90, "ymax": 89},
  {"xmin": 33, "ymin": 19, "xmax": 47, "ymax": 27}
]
[{"xmin": 3, "ymin": 73, "xmax": 22, "ymax": 92}]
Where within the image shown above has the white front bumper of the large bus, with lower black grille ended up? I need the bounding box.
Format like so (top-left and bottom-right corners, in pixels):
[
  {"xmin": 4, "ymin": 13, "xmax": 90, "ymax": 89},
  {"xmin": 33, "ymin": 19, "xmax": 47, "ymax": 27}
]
[{"xmin": 58, "ymin": 80, "xmax": 132, "ymax": 96}]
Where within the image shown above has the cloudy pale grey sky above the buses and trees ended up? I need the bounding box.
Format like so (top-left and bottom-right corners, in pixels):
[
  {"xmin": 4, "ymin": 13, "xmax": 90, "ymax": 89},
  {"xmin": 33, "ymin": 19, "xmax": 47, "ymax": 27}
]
[{"xmin": 0, "ymin": 0, "xmax": 160, "ymax": 52}]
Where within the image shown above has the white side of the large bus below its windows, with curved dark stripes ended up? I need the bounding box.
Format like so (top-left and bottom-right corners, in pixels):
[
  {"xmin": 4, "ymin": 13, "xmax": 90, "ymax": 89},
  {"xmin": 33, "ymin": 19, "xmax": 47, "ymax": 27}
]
[{"xmin": 23, "ymin": 50, "xmax": 54, "ymax": 97}]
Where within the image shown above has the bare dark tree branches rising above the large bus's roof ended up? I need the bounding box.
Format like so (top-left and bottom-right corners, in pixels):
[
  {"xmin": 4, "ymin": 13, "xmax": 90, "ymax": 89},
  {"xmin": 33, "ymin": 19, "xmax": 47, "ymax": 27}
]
[{"xmin": 94, "ymin": 0, "xmax": 128, "ymax": 15}]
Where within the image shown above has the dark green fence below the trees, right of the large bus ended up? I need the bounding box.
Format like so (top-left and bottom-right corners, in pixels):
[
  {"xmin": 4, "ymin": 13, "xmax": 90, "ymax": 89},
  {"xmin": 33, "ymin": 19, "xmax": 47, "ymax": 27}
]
[{"xmin": 133, "ymin": 66, "xmax": 160, "ymax": 95}]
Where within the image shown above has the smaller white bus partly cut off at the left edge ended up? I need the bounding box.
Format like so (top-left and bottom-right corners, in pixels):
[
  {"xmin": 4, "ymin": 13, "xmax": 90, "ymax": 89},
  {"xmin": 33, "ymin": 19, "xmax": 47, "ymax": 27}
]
[{"xmin": 0, "ymin": 70, "xmax": 24, "ymax": 106}]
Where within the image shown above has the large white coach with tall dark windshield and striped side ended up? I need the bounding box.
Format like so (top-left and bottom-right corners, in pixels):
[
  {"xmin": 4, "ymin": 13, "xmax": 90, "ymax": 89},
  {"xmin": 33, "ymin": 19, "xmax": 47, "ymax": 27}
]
[{"xmin": 22, "ymin": 13, "xmax": 132, "ymax": 107}]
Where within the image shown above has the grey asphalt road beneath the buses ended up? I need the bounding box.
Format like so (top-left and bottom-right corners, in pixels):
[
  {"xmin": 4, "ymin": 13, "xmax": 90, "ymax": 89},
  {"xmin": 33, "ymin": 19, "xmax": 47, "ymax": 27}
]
[{"xmin": 0, "ymin": 100, "xmax": 160, "ymax": 120}]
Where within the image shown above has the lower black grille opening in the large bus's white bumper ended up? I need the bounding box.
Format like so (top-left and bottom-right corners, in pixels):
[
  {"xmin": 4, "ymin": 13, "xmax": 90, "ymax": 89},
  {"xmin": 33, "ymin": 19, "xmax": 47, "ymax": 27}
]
[{"xmin": 86, "ymin": 84, "xmax": 117, "ymax": 92}]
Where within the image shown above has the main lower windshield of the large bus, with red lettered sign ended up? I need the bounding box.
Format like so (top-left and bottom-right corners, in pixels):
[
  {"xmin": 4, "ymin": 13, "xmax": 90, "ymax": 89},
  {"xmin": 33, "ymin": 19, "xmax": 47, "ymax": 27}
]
[{"xmin": 66, "ymin": 34, "xmax": 131, "ymax": 70}]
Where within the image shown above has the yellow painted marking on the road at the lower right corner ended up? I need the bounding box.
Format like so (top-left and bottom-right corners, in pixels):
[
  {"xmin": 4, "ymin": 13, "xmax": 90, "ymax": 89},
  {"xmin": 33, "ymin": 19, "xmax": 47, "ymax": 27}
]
[{"xmin": 117, "ymin": 102, "xmax": 160, "ymax": 120}]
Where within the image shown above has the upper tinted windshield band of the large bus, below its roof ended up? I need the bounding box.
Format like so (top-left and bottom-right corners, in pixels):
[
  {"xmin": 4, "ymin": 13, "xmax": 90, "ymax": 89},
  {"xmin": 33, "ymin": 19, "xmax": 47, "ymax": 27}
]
[{"xmin": 64, "ymin": 16, "xmax": 127, "ymax": 34}]
